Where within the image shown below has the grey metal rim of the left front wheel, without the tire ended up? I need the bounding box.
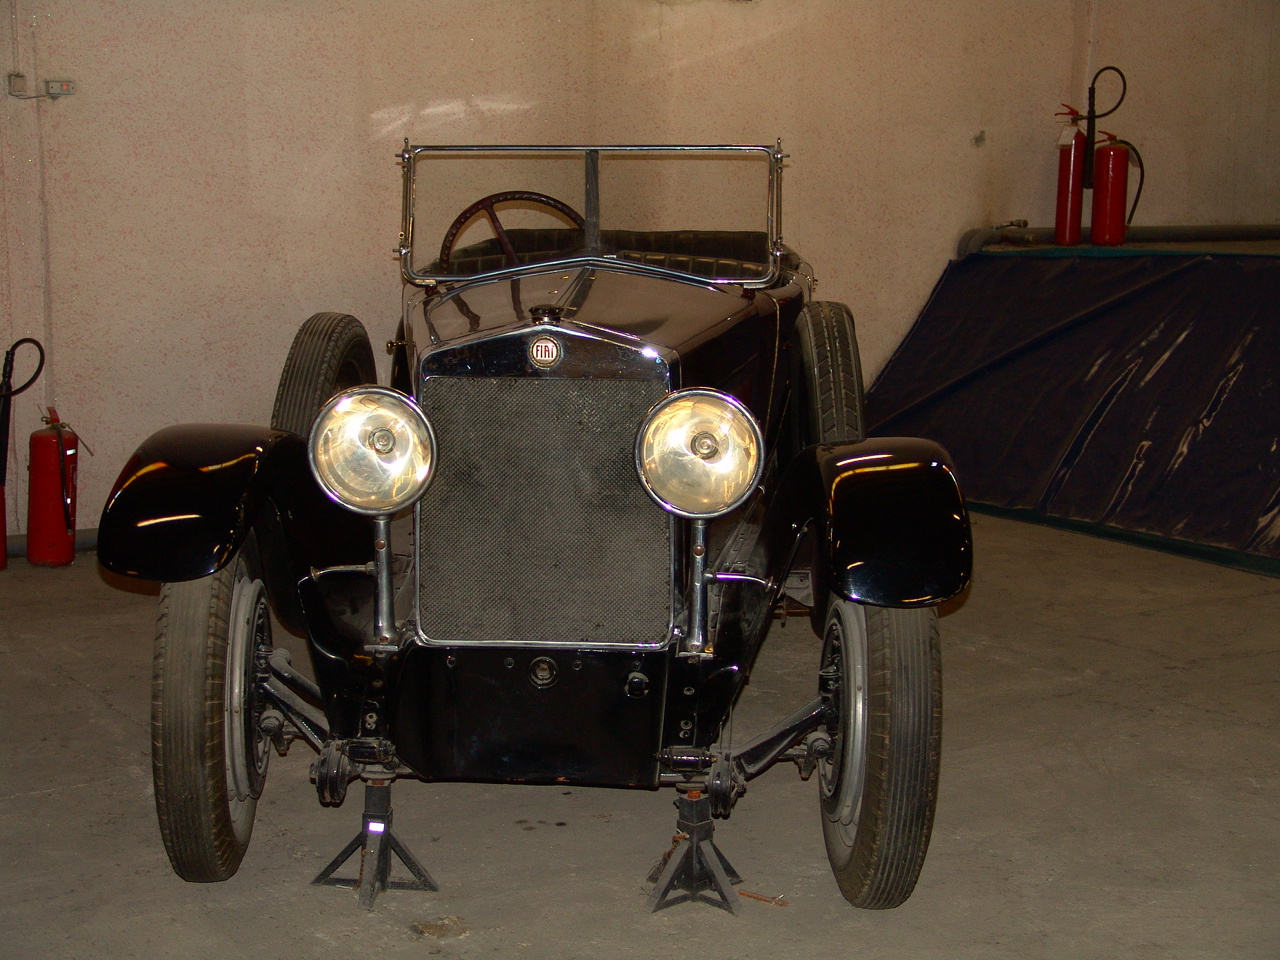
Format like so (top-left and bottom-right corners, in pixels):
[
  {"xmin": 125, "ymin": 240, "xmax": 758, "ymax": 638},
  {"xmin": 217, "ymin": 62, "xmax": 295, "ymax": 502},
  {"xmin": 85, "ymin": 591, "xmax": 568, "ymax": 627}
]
[{"xmin": 223, "ymin": 561, "xmax": 271, "ymax": 824}]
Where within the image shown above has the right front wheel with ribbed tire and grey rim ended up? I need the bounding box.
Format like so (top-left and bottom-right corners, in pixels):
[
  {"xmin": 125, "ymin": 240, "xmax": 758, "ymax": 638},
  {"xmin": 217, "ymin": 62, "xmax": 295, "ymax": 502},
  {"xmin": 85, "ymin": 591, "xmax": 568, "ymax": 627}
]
[{"xmin": 818, "ymin": 596, "xmax": 942, "ymax": 909}]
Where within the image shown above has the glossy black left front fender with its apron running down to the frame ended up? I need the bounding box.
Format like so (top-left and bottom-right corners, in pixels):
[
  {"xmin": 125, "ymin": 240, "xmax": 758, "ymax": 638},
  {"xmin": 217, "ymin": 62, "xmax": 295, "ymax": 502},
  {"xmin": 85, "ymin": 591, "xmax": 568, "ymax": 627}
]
[{"xmin": 97, "ymin": 424, "xmax": 374, "ymax": 737}]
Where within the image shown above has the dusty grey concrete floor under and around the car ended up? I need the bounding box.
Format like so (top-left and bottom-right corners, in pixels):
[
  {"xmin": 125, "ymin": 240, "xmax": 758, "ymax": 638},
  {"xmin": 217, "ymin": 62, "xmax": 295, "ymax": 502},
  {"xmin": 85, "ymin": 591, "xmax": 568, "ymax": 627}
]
[{"xmin": 0, "ymin": 517, "xmax": 1280, "ymax": 960}]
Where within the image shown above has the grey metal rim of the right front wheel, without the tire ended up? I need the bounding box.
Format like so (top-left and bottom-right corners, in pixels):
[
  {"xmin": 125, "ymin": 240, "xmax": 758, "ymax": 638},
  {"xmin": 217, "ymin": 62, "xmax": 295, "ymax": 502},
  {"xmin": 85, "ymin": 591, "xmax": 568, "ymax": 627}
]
[{"xmin": 818, "ymin": 603, "xmax": 867, "ymax": 846}]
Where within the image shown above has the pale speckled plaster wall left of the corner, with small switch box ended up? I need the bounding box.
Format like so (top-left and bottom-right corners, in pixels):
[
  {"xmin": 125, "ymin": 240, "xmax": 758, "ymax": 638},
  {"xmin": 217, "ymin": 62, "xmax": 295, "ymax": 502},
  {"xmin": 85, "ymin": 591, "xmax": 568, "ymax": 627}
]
[{"xmin": 0, "ymin": 0, "xmax": 595, "ymax": 534}]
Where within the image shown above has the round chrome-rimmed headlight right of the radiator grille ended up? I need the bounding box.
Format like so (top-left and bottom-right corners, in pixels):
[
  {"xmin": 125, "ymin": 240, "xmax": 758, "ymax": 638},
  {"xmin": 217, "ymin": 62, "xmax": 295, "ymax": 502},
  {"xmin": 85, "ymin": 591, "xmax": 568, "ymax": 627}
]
[{"xmin": 636, "ymin": 388, "xmax": 764, "ymax": 520}]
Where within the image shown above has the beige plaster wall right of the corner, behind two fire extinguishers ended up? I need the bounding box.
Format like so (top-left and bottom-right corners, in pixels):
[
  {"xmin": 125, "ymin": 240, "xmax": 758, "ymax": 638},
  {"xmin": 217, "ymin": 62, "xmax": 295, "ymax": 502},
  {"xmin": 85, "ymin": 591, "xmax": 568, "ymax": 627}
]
[{"xmin": 596, "ymin": 0, "xmax": 1280, "ymax": 383}]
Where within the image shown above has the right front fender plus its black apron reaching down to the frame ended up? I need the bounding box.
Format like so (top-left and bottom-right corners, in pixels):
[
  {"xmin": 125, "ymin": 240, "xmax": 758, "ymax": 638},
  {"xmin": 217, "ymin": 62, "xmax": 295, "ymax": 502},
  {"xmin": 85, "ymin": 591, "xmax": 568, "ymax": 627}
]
[{"xmin": 668, "ymin": 438, "xmax": 973, "ymax": 748}]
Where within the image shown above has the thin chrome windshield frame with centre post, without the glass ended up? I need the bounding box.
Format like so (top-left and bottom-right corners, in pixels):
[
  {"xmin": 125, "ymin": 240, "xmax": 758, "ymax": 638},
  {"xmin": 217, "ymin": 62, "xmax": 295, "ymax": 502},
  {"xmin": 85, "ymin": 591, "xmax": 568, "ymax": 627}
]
[{"xmin": 396, "ymin": 140, "xmax": 787, "ymax": 289}]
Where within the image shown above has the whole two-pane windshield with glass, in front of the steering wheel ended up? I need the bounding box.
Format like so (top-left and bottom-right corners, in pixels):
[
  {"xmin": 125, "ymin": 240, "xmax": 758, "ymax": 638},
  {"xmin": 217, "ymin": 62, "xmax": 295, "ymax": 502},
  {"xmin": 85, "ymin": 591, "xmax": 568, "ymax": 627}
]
[{"xmin": 401, "ymin": 143, "xmax": 782, "ymax": 285}]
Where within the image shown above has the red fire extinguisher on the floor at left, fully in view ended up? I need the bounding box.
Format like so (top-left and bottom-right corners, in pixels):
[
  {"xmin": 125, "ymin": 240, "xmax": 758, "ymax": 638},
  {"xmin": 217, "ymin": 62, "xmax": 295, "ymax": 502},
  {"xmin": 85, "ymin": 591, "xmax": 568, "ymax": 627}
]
[{"xmin": 27, "ymin": 407, "xmax": 79, "ymax": 567}]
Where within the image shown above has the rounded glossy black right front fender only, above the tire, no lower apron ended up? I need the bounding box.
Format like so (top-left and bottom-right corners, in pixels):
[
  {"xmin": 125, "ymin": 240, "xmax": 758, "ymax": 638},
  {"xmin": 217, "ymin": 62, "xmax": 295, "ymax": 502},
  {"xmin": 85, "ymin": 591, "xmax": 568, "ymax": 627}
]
[{"xmin": 765, "ymin": 436, "xmax": 973, "ymax": 607}]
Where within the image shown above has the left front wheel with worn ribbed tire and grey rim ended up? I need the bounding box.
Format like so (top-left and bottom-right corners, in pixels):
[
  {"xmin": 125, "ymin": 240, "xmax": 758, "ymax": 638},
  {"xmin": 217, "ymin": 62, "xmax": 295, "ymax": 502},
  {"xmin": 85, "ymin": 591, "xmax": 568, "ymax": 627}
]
[{"xmin": 151, "ymin": 539, "xmax": 271, "ymax": 883}]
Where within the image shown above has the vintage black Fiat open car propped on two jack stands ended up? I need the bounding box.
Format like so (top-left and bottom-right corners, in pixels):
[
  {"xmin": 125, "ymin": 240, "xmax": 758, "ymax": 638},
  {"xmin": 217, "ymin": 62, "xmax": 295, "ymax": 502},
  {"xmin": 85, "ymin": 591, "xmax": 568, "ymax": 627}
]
[{"xmin": 99, "ymin": 141, "xmax": 972, "ymax": 910}]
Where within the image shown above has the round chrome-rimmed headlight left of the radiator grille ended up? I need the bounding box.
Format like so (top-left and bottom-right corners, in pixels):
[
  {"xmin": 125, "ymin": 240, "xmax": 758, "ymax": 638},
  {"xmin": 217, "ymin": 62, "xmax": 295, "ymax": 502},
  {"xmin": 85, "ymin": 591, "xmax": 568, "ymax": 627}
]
[{"xmin": 308, "ymin": 387, "xmax": 435, "ymax": 515}]
